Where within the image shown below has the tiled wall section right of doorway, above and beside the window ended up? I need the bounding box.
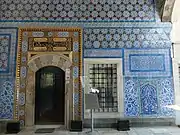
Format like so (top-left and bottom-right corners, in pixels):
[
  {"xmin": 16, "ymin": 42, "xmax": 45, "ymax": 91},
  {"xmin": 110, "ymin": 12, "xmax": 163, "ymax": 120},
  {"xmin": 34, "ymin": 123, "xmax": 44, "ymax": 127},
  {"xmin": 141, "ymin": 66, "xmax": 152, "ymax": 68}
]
[{"xmin": 84, "ymin": 25, "xmax": 174, "ymax": 117}]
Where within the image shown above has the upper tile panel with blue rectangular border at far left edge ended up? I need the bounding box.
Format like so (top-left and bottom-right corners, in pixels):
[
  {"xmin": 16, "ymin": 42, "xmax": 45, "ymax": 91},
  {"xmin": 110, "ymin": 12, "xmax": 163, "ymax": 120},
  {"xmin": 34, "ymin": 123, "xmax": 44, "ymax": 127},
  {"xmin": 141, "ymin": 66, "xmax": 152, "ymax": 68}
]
[{"xmin": 0, "ymin": 27, "xmax": 18, "ymax": 78}]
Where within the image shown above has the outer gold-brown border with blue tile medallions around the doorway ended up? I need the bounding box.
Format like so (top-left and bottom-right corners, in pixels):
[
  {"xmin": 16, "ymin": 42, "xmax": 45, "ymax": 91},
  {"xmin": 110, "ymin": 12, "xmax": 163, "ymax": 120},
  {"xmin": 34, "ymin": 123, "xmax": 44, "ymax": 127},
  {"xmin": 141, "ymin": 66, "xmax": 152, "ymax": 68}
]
[{"xmin": 15, "ymin": 28, "xmax": 82, "ymax": 125}]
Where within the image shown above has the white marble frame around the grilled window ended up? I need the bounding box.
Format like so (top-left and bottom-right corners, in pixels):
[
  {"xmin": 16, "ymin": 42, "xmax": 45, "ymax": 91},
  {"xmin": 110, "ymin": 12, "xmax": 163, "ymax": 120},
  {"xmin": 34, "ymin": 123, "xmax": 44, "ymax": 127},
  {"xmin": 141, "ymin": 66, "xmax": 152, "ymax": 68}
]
[{"xmin": 84, "ymin": 58, "xmax": 124, "ymax": 119}]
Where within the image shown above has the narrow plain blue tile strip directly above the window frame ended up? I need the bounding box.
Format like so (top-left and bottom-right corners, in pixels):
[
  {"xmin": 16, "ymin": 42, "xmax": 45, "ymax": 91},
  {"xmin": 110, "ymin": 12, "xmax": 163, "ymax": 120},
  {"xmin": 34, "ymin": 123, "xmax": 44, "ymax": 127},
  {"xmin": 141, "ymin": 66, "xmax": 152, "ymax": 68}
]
[{"xmin": 84, "ymin": 49, "xmax": 122, "ymax": 58}]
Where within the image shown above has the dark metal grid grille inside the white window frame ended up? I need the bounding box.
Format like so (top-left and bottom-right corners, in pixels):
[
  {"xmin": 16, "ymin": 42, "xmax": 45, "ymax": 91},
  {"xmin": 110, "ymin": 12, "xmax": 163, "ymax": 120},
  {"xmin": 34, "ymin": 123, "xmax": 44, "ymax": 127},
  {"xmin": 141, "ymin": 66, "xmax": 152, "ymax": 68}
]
[{"xmin": 89, "ymin": 64, "xmax": 118, "ymax": 112}]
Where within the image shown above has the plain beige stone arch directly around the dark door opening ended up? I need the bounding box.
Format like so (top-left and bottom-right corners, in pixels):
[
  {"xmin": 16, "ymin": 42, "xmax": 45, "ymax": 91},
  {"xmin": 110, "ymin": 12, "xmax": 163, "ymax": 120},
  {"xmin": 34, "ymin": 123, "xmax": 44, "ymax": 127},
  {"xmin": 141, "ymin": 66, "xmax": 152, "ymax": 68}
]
[{"xmin": 25, "ymin": 53, "xmax": 73, "ymax": 128}]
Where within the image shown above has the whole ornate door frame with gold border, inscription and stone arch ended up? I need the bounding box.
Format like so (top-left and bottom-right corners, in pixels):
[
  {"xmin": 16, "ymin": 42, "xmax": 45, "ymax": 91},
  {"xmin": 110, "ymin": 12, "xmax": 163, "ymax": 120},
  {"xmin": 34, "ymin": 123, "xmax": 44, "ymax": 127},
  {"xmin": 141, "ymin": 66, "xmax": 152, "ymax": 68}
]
[{"xmin": 14, "ymin": 26, "xmax": 83, "ymax": 129}]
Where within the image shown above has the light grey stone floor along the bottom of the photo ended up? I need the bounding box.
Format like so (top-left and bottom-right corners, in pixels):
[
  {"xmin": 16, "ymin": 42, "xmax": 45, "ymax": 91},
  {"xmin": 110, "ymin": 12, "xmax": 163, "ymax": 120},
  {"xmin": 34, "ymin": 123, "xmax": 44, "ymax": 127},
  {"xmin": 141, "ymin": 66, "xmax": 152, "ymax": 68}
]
[{"xmin": 2, "ymin": 126, "xmax": 180, "ymax": 135}]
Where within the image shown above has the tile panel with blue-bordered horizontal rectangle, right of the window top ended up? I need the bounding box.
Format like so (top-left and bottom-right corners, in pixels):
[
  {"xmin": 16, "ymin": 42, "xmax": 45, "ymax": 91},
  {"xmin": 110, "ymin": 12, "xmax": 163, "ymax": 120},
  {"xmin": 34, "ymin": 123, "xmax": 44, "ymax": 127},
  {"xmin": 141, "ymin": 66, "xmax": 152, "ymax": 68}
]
[{"xmin": 124, "ymin": 49, "xmax": 172, "ymax": 77}]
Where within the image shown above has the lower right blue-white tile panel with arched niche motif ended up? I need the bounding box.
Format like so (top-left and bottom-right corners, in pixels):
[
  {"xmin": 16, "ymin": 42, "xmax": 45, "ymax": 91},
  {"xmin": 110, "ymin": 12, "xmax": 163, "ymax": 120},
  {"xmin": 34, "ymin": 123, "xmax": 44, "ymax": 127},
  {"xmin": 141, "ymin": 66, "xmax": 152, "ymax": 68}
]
[{"xmin": 124, "ymin": 77, "xmax": 174, "ymax": 117}]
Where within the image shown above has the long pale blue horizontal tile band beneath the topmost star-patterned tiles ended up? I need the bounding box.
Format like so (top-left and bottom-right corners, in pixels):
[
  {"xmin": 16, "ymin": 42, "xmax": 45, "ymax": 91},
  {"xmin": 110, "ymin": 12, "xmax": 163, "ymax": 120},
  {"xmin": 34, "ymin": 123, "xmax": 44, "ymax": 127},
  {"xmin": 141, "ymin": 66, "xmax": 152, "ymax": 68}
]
[{"xmin": 0, "ymin": 21, "xmax": 172, "ymax": 28}]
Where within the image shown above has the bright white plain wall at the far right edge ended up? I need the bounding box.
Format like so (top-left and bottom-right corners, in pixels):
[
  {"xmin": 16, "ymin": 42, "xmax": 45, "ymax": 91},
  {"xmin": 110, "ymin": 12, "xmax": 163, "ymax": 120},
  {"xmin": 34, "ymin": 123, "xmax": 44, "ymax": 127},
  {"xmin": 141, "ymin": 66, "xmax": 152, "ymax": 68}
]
[{"xmin": 171, "ymin": 0, "xmax": 180, "ymax": 125}]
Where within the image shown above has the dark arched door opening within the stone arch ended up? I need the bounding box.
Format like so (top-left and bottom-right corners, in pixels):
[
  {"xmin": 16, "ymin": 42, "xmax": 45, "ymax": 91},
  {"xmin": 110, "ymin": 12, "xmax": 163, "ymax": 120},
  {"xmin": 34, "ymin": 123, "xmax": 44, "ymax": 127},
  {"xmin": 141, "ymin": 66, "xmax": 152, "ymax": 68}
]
[{"xmin": 34, "ymin": 66, "xmax": 65, "ymax": 124}]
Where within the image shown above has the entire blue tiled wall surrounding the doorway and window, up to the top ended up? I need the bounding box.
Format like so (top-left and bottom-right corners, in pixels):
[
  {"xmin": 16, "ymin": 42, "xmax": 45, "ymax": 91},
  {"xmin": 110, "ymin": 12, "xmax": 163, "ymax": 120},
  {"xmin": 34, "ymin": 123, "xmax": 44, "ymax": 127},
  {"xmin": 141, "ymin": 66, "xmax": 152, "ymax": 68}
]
[{"xmin": 0, "ymin": 0, "xmax": 174, "ymax": 119}]
